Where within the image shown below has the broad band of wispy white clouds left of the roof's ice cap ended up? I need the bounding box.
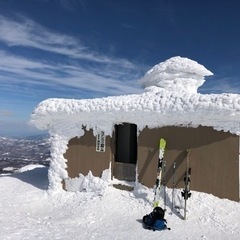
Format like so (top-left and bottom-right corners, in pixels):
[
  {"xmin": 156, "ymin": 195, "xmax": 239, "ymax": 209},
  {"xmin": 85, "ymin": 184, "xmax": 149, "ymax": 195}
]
[{"xmin": 0, "ymin": 16, "xmax": 143, "ymax": 95}]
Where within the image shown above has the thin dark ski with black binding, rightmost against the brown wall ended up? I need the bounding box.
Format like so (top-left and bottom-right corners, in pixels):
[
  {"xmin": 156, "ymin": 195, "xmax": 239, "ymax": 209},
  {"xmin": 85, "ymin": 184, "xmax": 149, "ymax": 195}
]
[{"xmin": 182, "ymin": 150, "xmax": 191, "ymax": 220}]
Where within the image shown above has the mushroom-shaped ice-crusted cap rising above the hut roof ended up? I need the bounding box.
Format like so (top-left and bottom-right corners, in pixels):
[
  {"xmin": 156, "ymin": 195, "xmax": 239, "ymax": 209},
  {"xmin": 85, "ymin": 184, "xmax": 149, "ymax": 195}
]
[{"xmin": 140, "ymin": 56, "xmax": 213, "ymax": 93}]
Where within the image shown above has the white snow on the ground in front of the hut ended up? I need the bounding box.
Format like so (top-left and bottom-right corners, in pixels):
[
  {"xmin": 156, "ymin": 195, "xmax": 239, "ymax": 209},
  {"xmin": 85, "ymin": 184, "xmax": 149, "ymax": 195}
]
[{"xmin": 0, "ymin": 165, "xmax": 240, "ymax": 240}]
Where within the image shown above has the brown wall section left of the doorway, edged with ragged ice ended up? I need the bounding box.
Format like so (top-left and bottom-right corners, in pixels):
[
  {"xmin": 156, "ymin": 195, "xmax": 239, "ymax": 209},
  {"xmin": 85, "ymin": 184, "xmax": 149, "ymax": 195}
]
[{"xmin": 64, "ymin": 130, "xmax": 111, "ymax": 178}]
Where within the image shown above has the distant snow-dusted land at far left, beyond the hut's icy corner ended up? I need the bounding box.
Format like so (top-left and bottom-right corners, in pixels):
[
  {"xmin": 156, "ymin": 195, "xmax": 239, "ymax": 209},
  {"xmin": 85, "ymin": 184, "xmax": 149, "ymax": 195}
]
[{"xmin": 0, "ymin": 135, "xmax": 50, "ymax": 172}]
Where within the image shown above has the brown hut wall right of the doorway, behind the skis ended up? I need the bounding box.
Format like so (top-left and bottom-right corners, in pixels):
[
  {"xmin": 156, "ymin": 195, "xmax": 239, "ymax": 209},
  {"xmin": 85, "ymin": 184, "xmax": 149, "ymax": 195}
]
[{"xmin": 138, "ymin": 127, "xmax": 239, "ymax": 201}]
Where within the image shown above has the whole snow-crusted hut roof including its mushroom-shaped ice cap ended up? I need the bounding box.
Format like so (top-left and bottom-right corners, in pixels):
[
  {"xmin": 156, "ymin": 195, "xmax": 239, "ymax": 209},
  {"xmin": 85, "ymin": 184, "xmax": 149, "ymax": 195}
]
[{"xmin": 31, "ymin": 57, "xmax": 240, "ymax": 136}]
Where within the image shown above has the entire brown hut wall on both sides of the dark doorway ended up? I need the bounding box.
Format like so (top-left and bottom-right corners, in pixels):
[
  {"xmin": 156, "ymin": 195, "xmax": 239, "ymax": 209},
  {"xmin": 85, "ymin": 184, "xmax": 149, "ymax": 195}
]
[{"xmin": 64, "ymin": 124, "xmax": 239, "ymax": 201}]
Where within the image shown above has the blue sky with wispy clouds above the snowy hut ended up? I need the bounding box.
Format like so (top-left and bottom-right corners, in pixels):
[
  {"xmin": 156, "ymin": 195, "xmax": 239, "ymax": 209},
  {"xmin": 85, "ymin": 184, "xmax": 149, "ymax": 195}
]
[{"xmin": 0, "ymin": 0, "xmax": 240, "ymax": 136}]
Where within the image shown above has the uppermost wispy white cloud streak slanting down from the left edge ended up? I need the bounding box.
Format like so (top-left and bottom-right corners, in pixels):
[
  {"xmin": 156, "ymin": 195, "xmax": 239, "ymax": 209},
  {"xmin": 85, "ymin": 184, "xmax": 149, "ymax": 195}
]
[{"xmin": 0, "ymin": 15, "xmax": 135, "ymax": 68}]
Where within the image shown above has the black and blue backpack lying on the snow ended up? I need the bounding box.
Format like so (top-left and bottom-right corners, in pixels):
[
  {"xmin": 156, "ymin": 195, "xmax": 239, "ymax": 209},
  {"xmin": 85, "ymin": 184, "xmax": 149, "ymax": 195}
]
[{"xmin": 143, "ymin": 207, "xmax": 170, "ymax": 231}]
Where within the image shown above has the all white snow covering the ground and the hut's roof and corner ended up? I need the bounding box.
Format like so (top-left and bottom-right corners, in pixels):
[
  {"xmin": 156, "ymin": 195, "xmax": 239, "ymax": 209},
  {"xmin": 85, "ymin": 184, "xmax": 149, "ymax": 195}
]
[{"xmin": 0, "ymin": 57, "xmax": 240, "ymax": 240}]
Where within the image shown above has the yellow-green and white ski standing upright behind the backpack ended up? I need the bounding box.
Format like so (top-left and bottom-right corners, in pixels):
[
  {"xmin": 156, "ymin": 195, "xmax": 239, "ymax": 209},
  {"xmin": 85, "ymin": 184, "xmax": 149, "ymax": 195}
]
[{"xmin": 153, "ymin": 138, "xmax": 167, "ymax": 207}]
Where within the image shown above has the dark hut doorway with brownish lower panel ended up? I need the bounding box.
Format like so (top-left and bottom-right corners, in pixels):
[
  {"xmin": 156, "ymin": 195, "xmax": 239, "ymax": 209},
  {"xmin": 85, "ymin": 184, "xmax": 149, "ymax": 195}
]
[{"xmin": 113, "ymin": 123, "xmax": 137, "ymax": 181}]
